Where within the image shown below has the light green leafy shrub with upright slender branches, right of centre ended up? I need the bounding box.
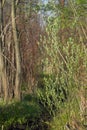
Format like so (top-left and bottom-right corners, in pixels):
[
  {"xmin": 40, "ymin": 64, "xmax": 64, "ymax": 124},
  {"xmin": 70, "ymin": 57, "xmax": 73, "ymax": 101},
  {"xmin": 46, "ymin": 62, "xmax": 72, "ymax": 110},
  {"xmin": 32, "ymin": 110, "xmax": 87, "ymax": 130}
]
[{"xmin": 37, "ymin": 31, "xmax": 87, "ymax": 119}]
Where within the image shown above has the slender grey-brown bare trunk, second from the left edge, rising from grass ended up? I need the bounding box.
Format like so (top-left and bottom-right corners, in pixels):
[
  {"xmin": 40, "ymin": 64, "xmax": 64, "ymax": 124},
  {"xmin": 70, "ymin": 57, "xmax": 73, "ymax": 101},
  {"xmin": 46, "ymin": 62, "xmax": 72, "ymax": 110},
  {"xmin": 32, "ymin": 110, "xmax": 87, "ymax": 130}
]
[{"xmin": 11, "ymin": 0, "xmax": 21, "ymax": 100}]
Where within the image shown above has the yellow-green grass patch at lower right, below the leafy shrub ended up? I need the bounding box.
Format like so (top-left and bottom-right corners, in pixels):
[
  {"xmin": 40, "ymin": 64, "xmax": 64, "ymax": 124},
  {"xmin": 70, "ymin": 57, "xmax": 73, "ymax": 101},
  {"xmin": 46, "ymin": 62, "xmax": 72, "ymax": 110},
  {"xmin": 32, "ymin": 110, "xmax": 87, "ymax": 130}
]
[{"xmin": 50, "ymin": 98, "xmax": 81, "ymax": 130}]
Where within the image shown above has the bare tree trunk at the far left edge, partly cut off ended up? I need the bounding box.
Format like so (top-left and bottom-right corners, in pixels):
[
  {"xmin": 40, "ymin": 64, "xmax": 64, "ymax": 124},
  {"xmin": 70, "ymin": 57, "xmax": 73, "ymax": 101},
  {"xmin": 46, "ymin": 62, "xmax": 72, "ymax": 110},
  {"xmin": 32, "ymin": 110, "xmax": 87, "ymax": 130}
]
[{"xmin": 0, "ymin": 0, "xmax": 9, "ymax": 102}]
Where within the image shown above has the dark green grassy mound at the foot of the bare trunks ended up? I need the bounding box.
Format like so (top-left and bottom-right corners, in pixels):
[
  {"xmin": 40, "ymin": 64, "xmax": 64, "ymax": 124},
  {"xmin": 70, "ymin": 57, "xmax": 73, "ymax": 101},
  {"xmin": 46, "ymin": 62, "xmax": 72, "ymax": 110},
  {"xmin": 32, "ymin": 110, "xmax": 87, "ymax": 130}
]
[{"xmin": 0, "ymin": 96, "xmax": 41, "ymax": 130}]
